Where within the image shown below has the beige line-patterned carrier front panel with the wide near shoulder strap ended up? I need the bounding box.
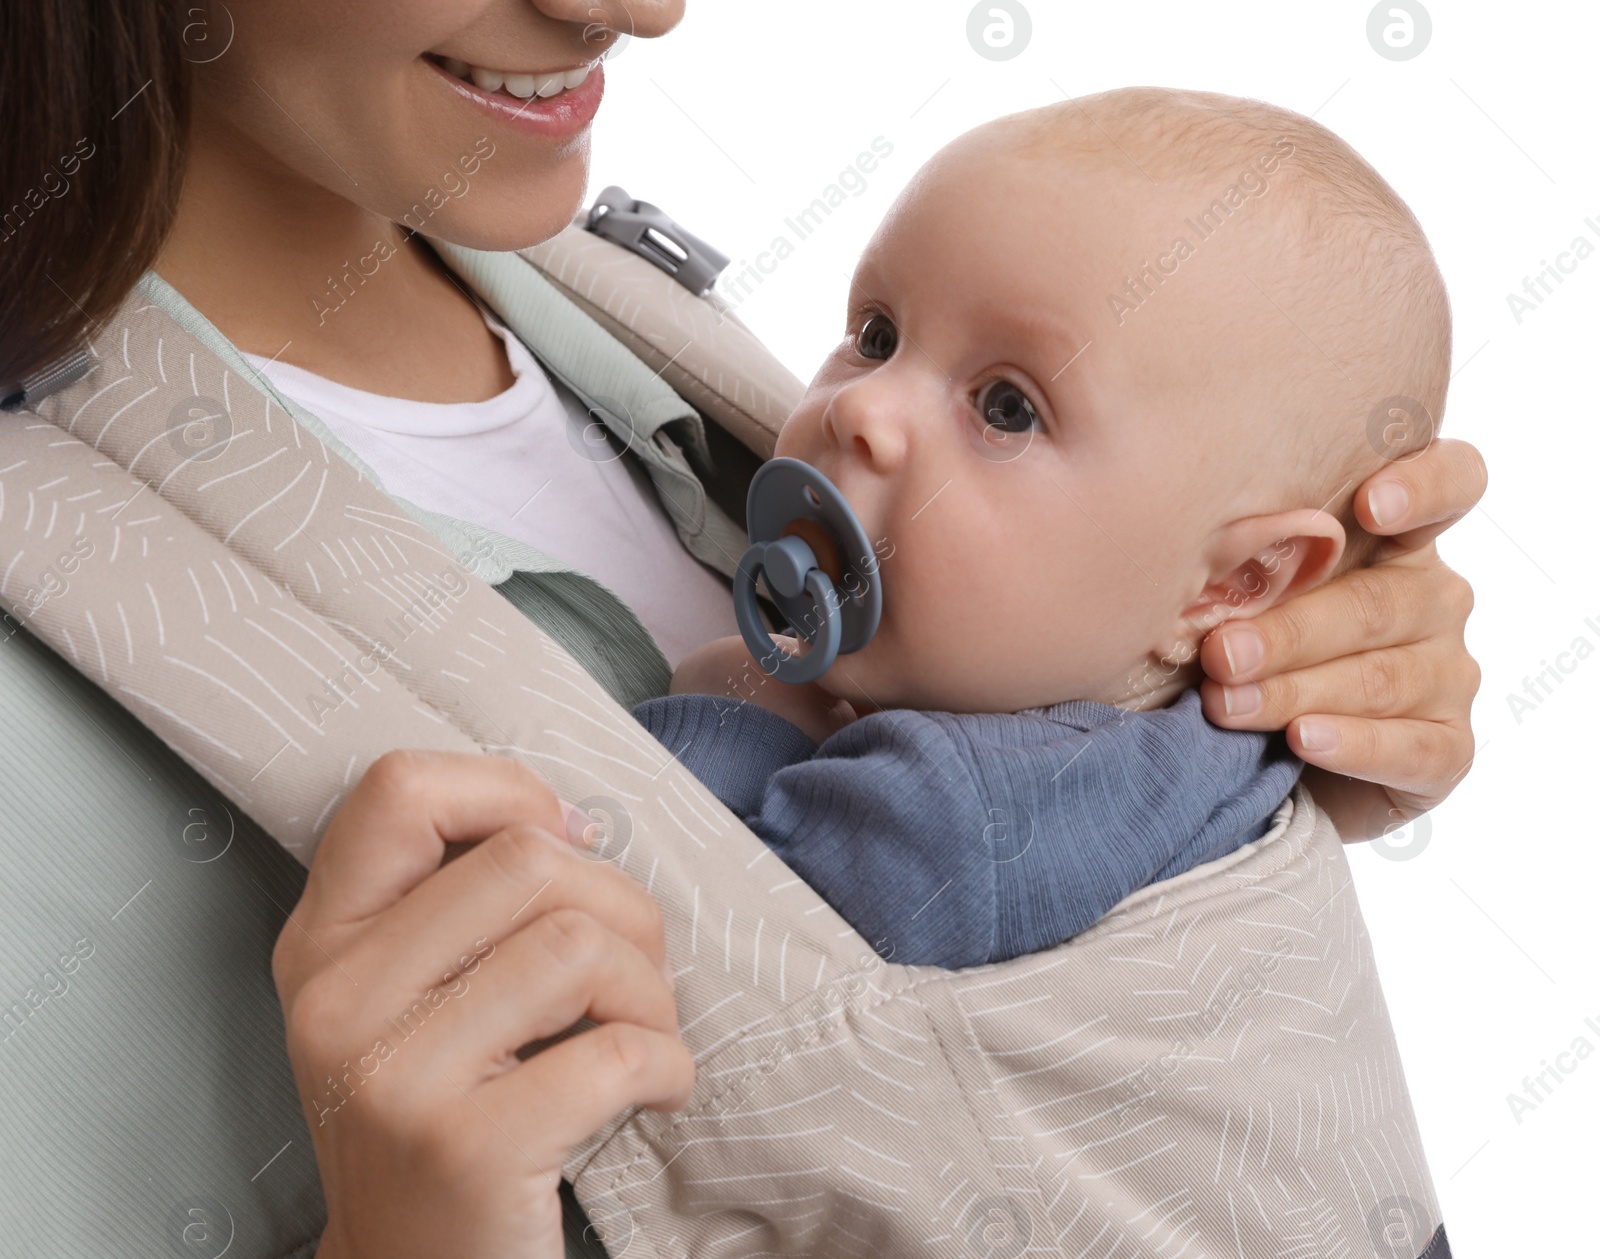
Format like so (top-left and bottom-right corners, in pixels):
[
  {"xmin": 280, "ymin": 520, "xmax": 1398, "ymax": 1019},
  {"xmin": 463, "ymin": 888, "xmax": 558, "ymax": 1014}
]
[{"xmin": 0, "ymin": 286, "xmax": 1438, "ymax": 1259}]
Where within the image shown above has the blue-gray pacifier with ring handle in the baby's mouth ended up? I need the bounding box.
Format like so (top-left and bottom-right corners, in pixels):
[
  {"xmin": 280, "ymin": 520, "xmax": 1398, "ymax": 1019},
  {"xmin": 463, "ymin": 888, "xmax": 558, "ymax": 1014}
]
[{"xmin": 733, "ymin": 459, "xmax": 883, "ymax": 685}]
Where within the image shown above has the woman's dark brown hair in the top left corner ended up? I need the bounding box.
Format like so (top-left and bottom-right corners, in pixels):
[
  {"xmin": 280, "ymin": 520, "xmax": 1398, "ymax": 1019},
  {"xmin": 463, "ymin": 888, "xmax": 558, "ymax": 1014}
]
[{"xmin": 0, "ymin": 0, "xmax": 197, "ymax": 392}]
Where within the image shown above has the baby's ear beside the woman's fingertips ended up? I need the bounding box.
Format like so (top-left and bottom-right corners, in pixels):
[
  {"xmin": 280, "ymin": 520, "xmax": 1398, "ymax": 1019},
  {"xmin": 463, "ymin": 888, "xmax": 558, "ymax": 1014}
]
[{"xmin": 1182, "ymin": 507, "xmax": 1344, "ymax": 629}]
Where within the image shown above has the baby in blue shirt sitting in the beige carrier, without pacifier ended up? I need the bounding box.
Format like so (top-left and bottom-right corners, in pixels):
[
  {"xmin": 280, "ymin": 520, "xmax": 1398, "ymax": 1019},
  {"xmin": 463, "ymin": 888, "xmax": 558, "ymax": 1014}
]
[{"xmin": 635, "ymin": 88, "xmax": 1450, "ymax": 968}]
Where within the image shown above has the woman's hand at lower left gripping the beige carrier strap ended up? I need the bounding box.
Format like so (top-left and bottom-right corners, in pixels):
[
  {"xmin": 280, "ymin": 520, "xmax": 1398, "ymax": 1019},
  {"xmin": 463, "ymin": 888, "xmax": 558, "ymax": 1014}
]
[{"xmin": 272, "ymin": 752, "xmax": 694, "ymax": 1259}]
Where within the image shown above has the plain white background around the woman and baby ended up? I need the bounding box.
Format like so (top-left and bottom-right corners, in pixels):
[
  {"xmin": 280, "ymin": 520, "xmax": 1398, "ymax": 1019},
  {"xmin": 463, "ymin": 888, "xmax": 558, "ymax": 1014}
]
[{"xmin": 590, "ymin": 0, "xmax": 1600, "ymax": 1256}]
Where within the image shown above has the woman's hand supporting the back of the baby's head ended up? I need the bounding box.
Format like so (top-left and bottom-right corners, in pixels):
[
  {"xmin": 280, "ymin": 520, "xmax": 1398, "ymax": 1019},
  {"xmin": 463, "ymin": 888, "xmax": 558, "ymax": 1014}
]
[{"xmin": 1200, "ymin": 440, "xmax": 1488, "ymax": 841}]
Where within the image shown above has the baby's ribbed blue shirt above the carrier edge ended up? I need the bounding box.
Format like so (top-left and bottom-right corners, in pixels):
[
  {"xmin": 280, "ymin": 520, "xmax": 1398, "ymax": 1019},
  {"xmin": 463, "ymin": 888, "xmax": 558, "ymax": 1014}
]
[{"xmin": 634, "ymin": 691, "xmax": 1301, "ymax": 968}]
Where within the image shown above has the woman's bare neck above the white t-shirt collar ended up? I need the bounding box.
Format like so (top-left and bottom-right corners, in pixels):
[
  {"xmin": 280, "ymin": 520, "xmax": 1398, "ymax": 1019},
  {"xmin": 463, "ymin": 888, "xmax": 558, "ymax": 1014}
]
[{"xmin": 155, "ymin": 112, "xmax": 514, "ymax": 402}]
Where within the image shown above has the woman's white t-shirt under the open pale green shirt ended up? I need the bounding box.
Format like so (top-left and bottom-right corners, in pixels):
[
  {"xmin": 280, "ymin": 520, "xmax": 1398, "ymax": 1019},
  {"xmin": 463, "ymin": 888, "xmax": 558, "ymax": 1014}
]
[{"xmin": 236, "ymin": 312, "xmax": 738, "ymax": 669}]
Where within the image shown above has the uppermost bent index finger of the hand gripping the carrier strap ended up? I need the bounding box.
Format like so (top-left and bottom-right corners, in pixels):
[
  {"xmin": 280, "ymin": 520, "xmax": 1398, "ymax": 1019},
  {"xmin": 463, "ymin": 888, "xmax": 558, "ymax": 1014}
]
[{"xmin": 298, "ymin": 752, "xmax": 565, "ymax": 926}]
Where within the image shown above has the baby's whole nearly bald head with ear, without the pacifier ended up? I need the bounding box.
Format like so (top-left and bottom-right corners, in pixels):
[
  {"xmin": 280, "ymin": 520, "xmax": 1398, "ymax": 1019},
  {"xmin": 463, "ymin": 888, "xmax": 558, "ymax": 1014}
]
[{"xmin": 778, "ymin": 88, "xmax": 1450, "ymax": 712}]
